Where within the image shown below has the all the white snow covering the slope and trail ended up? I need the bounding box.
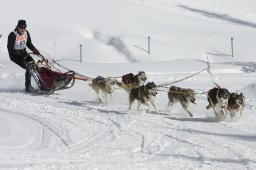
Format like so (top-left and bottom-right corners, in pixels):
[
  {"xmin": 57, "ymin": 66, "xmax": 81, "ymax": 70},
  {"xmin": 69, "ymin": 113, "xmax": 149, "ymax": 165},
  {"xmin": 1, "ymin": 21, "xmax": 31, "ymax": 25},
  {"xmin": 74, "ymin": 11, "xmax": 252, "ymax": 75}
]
[{"xmin": 0, "ymin": 0, "xmax": 256, "ymax": 170}]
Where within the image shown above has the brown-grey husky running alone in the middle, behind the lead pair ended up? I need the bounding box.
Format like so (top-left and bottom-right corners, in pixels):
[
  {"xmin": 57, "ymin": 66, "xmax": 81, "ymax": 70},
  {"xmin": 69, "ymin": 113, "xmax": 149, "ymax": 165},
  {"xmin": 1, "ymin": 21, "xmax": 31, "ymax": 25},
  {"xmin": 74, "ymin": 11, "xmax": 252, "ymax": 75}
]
[{"xmin": 168, "ymin": 86, "xmax": 196, "ymax": 117}]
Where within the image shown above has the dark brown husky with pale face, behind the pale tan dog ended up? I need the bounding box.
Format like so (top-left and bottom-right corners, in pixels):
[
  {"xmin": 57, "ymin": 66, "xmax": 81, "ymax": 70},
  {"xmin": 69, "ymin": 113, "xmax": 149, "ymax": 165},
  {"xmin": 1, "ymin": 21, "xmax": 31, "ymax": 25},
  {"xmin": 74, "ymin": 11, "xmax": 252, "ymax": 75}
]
[{"xmin": 117, "ymin": 71, "xmax": 147, "ymax": 91}]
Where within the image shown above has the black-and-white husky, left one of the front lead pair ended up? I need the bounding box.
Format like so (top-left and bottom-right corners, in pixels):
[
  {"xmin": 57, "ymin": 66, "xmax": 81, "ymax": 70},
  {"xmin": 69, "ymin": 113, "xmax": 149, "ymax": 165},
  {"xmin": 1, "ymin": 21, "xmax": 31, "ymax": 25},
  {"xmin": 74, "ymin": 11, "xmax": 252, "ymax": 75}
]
[{"xmin": 206, "ymin": 87, "xmax": 230, "ymax": 116}]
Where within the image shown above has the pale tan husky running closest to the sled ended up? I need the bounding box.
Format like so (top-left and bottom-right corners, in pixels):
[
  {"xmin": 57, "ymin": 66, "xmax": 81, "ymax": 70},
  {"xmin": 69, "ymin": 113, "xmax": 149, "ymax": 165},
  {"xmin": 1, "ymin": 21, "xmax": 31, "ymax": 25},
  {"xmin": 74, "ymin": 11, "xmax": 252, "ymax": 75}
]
[{"xmin": 89, "ymin": 76, "xmax": 116, "ymax": 103}]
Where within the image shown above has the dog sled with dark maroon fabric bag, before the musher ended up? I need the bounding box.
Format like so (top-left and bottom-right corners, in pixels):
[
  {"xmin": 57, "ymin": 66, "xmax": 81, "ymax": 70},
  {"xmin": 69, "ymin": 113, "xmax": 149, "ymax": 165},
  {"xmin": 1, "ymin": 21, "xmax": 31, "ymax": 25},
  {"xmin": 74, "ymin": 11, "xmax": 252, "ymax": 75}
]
[{"xmin": 28, "ymin": 55, "xmax": 75, "ymax": 94}]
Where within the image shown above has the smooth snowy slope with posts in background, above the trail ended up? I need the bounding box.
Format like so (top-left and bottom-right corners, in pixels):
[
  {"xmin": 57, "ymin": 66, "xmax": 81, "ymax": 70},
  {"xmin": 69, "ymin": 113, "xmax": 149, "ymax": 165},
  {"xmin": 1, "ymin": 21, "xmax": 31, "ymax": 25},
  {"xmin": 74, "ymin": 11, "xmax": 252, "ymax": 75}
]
[{"xmin": 0, "ymin": 0, "xmax": 256, "ymax": 63}]
